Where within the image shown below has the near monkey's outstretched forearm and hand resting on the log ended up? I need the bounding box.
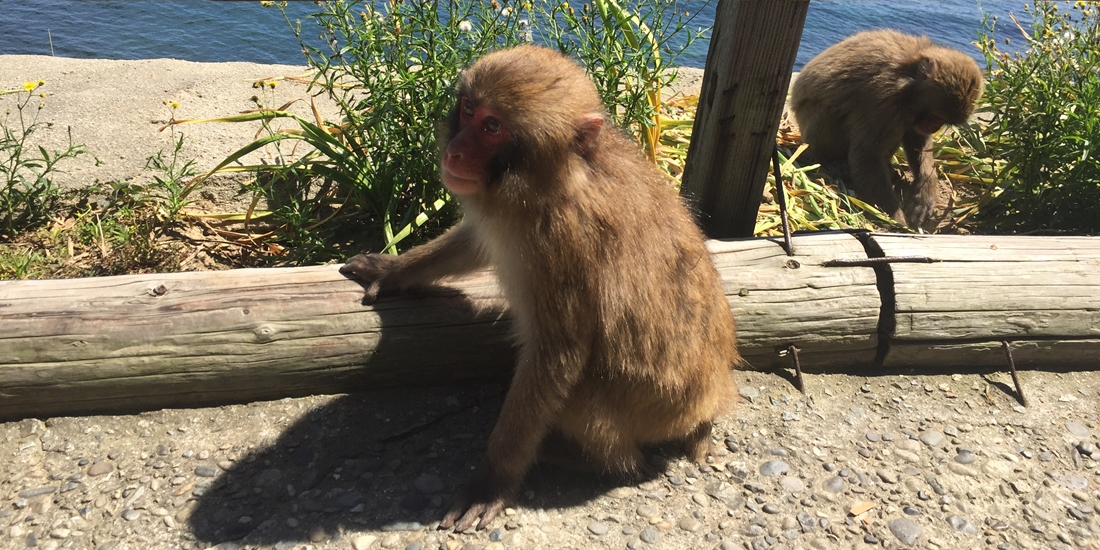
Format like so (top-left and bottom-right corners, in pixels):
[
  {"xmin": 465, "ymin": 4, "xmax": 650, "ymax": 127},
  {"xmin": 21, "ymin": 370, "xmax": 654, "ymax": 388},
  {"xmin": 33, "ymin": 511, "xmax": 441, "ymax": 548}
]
[{"xmin": 340, "ymin": 222, "xmax": 487, "ymax": 304}]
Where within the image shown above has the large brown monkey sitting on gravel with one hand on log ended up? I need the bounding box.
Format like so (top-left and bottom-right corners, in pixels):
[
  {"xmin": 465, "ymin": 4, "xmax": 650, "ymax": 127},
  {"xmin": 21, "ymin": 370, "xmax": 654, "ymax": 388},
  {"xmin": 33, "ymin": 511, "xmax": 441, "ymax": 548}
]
[{"xmin": 340, "ymin": 45, "xmax": 739, "ymax": 531}]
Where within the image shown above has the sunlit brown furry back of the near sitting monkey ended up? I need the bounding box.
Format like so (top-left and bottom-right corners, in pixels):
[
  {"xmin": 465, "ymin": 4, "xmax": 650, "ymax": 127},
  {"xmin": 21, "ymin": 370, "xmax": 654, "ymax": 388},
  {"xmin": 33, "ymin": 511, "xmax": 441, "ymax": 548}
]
[{"xmin": 550, "ymin": 131, "xmax": 740, "ymax": 451}]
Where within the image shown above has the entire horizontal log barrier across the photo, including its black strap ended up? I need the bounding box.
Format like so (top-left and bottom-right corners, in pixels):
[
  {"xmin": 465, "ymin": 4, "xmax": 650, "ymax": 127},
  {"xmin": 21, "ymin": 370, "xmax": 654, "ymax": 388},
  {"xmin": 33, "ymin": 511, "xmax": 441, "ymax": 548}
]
[{"xmin": 0, "ymin": 232, "xmax": 1100, "ymax": 419}]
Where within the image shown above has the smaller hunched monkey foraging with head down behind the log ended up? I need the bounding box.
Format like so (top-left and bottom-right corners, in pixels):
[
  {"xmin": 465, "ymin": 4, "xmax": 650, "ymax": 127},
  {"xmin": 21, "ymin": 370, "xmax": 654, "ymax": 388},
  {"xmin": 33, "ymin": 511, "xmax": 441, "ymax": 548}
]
[{"xmin": 791, "ymin": 30, "xmax": 983, "ymax": 228}]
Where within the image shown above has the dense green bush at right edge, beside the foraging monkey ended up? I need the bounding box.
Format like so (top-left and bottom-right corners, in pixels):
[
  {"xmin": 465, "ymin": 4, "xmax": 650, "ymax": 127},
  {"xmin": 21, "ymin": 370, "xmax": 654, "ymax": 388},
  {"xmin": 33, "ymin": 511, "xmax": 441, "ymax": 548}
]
[{"xmin": 969, "ymin": 0, "xmax": 1100, "ymax": 233}]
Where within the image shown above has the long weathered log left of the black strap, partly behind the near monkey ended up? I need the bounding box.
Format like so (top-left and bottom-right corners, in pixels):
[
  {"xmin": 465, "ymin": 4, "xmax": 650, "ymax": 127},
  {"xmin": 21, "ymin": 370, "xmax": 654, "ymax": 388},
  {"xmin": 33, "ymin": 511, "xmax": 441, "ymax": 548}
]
[{"xmin": 0, "ymin": 233, "xmax": 880, "ymax": 419}]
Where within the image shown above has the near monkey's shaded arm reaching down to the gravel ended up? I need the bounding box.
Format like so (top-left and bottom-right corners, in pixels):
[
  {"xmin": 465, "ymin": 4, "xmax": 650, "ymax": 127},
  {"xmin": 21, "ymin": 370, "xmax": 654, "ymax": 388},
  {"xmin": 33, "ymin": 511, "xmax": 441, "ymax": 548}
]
[{"xmin": 440, "ymin": 336, "xmax": 589, "ymax": 531}]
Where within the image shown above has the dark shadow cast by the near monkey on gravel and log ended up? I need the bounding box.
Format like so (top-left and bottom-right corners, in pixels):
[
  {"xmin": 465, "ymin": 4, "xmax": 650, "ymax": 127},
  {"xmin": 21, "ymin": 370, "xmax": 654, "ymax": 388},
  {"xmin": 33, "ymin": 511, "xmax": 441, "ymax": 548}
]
[{"xmin": 189, "ymin": 290, "xmax": 646, "ymax": 545}]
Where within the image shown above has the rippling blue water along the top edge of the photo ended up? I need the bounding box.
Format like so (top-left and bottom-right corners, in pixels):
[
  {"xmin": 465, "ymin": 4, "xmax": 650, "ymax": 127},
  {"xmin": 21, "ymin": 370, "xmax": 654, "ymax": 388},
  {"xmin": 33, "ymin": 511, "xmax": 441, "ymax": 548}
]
[{"xmin": 0, "ymin": 0, "xmax": 1030, "ymax": 69}]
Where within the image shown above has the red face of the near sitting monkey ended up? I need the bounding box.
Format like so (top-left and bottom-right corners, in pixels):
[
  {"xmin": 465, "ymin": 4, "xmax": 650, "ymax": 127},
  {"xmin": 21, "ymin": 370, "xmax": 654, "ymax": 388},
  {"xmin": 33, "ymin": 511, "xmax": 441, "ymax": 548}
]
[{"xmin": 442, "ymin": 96, "xmax": 509, "ymax": 197}]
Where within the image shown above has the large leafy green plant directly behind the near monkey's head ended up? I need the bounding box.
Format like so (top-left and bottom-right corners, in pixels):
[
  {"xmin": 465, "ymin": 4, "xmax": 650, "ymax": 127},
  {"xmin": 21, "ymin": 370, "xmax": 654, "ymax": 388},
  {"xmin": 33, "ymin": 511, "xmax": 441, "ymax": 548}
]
[{"xmin": 183, "ymin": 0, "xmax": 693, "ymax": 263}]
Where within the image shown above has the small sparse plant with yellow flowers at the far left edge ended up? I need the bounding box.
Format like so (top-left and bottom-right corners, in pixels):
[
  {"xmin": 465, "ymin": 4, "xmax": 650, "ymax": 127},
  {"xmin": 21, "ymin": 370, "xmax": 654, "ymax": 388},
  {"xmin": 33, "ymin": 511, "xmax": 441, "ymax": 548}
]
[{"xmin": 0, "ymin": 80, "xmax": 85, "ymax": 239}]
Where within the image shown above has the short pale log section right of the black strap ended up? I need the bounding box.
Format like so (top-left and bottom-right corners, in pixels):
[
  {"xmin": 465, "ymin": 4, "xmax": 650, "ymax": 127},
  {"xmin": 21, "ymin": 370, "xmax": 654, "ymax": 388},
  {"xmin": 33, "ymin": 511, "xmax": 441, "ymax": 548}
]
[{"xmin": 870, "ymin": 234, "xmax": 1100, "ymax": 369}]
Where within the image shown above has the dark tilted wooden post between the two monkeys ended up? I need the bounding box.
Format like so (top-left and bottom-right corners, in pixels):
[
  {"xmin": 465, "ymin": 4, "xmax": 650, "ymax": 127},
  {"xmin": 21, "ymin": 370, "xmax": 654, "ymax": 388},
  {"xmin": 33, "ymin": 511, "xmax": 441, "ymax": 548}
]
[{"xmin": 681, "ymin": 0, "xmax": 810, "ymax": 239}]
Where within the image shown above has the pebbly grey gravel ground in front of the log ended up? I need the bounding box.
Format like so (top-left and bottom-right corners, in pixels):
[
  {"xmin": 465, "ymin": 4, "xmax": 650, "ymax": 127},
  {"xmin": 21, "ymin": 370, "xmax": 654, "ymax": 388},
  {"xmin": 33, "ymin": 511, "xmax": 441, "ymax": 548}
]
[{"xmin": 0, "ymin": 371, "xmax": 1100, "ymax": 550}]
